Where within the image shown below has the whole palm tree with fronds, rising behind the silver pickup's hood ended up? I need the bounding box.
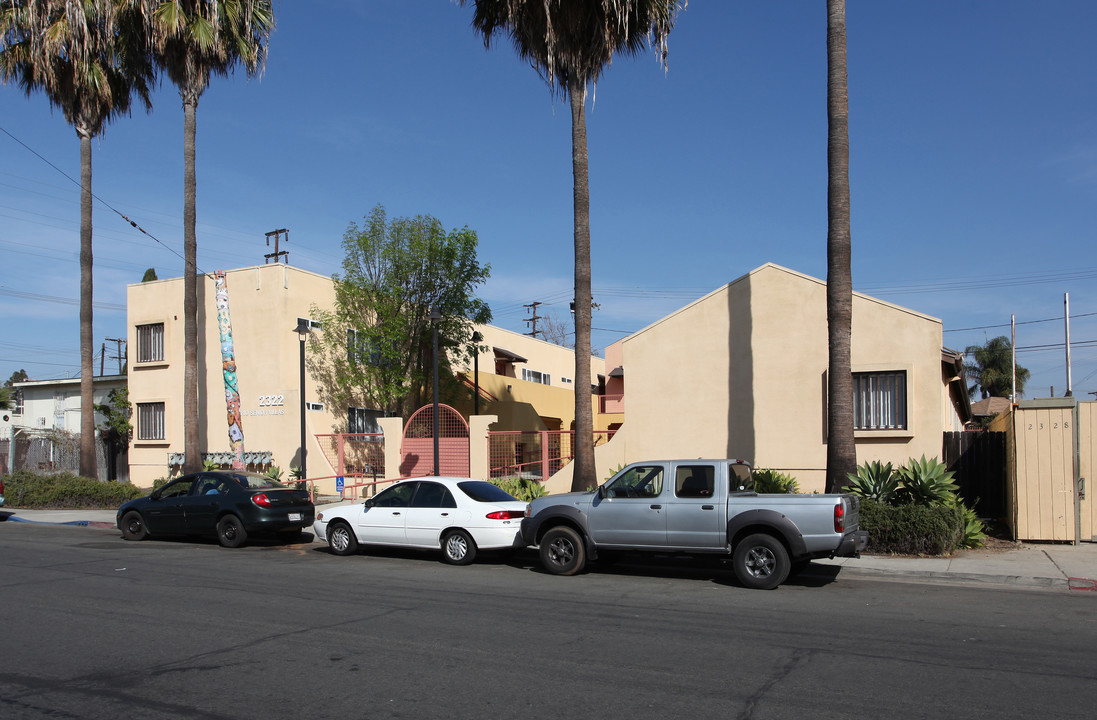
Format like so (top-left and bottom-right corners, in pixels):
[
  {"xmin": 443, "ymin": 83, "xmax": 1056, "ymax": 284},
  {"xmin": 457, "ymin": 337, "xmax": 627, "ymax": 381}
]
[{"xmin": 461, "ymin": 0, "xmax": 680, "ymax": 490}]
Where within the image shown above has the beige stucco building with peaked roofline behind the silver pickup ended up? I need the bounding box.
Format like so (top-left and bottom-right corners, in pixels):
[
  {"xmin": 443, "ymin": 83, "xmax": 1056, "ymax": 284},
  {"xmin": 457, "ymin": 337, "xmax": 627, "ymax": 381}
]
[{"xmin": 551, "ymin": 265, "xmax": 969, "ymax": 492}]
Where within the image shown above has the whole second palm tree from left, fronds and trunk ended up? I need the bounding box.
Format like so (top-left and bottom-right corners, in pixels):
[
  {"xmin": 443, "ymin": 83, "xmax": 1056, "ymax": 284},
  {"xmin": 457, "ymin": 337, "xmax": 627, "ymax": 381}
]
[{"xmin": 144, "ymin": 0, "xmax": 274, "ymax": 472}]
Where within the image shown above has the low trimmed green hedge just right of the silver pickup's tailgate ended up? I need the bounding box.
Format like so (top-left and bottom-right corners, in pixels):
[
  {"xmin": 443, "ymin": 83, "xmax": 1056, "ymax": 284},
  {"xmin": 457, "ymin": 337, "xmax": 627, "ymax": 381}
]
[{"xmin": 860, "ymin": 498, "xmax": 964, "ymax": 555}]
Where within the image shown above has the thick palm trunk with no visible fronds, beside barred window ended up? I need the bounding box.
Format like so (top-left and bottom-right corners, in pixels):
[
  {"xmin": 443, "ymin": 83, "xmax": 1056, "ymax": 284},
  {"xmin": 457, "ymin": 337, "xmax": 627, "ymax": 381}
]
[{"xmin": 826, "ymin": 0, "xmax": 857, "ymax": 493}]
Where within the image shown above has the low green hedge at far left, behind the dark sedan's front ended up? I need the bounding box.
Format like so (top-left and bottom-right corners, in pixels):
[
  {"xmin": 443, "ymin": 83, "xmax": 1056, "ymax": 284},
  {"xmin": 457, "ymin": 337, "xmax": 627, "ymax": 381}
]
[{"xmin": 3, "ymin": 470, "xmax": 145, "ymax": 509}]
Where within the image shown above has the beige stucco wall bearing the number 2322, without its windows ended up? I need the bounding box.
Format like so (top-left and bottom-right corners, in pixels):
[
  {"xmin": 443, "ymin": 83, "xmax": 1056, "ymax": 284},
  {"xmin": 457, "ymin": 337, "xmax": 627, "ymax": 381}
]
[{"xmin": 127, "ymin": 265, "xmax": 335, "ymax": 486}]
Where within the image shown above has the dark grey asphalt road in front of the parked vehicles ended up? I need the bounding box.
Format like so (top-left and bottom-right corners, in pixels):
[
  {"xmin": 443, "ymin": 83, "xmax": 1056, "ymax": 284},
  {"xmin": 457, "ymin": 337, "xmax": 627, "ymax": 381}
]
[{"xmin": 0, "ymin": 524, "xmax": 1097, "ymax": 720}]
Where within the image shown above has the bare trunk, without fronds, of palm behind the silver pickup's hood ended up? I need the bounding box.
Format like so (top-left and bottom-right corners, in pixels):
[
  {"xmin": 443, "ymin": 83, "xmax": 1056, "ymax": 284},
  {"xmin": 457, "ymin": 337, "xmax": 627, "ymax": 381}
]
[{"xmin": 567, "ymin": 78, "xmax": 598, "ymax": 491}]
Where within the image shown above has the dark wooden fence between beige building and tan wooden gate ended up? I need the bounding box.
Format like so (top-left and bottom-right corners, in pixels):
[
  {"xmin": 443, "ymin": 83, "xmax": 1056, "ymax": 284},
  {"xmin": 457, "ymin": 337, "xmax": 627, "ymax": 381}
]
[{"xmin": 943, "ymin": 430, "xmax": 1009, "ymax": 519}]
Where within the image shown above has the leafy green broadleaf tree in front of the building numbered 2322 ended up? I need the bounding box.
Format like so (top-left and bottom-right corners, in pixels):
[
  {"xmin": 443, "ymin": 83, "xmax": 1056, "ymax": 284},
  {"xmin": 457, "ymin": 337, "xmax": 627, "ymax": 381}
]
[{"xmin": 308, "ymin": 205, "xmax": 491, "ymax": 418}]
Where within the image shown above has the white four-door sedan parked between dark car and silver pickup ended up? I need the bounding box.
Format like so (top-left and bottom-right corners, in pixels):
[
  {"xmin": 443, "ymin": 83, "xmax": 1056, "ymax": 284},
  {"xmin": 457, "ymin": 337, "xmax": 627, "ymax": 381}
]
[{"xmin": 313, "ymin": 477, "xmax": 525, "ymax": 565}]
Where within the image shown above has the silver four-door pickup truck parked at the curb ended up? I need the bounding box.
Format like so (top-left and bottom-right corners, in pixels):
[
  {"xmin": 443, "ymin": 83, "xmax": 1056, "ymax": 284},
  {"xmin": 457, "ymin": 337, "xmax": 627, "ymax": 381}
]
[{"xmin": 522, "ymin": 460, "xmax": 868, "ymax": 589}]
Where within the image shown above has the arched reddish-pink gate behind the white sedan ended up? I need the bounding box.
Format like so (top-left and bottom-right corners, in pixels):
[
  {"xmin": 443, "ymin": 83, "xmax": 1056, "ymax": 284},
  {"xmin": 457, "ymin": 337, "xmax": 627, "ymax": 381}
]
[{"xmin": 400, "ymin": 405, "xmax": 468, "ymax": 477}]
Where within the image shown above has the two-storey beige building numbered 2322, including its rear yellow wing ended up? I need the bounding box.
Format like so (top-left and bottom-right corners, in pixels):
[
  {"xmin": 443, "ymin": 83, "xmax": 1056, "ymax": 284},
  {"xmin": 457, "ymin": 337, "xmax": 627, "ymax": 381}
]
[{"xmin": 127, "ymin": 265, "xmax": 604, "ymax": 492}]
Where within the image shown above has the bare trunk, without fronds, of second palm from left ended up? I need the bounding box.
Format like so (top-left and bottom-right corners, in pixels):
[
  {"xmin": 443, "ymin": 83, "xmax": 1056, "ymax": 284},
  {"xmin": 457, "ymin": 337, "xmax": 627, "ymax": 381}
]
[{"xmin": 181, "ymin": 97, "xmax": 202, "ymax": 473}]
